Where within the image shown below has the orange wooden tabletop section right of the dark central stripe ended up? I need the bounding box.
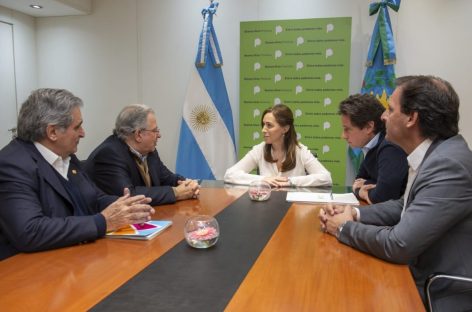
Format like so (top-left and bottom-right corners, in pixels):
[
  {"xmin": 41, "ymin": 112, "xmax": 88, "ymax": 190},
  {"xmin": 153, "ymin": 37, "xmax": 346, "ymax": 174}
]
[{"xmin": 225, "ymin": 204, "xmax": 424, "ymax": 312}]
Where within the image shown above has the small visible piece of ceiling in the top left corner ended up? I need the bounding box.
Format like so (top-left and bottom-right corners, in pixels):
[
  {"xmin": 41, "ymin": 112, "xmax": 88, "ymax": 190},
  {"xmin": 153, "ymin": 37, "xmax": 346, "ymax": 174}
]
[{"xmin": 0, "ymin": 0, "xmax": 92, "ymax": 17}]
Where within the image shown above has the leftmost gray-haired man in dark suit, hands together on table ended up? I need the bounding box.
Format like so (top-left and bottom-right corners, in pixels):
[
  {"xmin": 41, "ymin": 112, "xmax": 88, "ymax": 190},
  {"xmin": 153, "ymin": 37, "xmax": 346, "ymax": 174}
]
[{"xmin": 0, "ymin": 89, "xmax": 154, "ymax": 259}]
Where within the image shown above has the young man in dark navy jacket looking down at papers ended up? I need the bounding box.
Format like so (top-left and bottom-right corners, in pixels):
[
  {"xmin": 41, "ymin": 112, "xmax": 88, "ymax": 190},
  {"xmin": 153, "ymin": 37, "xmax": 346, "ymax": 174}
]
[{"xmin": 339, "ymin": 94, "xmax": 408, "ymax": 204}]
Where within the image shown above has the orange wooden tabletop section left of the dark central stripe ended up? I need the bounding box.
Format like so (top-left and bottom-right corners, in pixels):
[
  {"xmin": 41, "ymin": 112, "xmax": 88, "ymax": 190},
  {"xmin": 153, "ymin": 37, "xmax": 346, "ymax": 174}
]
[{"xmin": 0, "ymin": 188, "xmax": 245, "ymax": 312}]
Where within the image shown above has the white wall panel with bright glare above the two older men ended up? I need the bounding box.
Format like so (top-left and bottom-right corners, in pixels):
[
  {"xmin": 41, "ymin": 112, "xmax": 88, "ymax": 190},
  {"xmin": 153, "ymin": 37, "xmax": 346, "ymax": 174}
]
[{"xmin": 37, "ymin": 0, "xmax": 138, "ymax": 158}]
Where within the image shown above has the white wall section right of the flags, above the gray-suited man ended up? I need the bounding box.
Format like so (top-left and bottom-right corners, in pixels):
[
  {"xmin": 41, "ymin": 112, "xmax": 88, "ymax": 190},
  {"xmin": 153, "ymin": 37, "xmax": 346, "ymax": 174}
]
[{"xmin": 395, "ymin": 0, "xmax": 472, "ymax": 138}]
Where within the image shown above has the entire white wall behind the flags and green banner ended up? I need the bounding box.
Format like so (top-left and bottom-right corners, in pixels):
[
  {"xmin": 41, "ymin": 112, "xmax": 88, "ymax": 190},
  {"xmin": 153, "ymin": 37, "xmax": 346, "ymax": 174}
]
[{"xmin": 21, "ymin": 0, "xmax": 472, "ymax": 169}]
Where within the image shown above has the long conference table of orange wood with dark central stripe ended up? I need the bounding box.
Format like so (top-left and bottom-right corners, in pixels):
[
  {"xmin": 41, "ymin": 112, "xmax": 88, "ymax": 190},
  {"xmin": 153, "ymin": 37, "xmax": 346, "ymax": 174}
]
[{"xmin": 0, "ymin": 183, "xmax": 424, "ymax": 311}]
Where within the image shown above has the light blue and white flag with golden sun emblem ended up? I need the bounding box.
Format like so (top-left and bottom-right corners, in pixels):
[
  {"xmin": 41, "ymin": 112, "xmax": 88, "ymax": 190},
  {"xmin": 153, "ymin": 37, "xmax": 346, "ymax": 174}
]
[{"xmin": 176, "ymin": 2, "xmax": 236, "ymax": 180}]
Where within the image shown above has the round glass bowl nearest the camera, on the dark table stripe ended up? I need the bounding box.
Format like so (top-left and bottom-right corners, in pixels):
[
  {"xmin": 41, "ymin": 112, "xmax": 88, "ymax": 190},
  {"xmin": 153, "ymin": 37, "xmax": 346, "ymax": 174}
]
[{"xmin": 184, "ymin": 215, "xmax": 220, "ymax": 249}]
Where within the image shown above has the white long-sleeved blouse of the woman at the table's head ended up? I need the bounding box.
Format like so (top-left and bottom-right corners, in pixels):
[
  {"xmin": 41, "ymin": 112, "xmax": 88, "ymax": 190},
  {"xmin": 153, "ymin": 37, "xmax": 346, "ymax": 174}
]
[{"xmin": 224, "ymin": 142, "xmax": 332, "ymax": 186}]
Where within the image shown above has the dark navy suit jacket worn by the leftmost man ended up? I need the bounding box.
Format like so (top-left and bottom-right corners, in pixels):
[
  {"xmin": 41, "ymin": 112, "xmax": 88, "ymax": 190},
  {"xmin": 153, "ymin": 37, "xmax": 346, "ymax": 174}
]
[{"xmin": 0, "ymin": 139, "xmax": 116, "ymax": 259}]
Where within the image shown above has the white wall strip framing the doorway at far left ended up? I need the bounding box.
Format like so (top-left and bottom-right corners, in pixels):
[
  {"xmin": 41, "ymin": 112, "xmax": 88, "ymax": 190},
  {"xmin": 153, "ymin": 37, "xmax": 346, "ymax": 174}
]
[{"xmin": 0, "ymin": 6, "xmax": 38, "ymax": 107}]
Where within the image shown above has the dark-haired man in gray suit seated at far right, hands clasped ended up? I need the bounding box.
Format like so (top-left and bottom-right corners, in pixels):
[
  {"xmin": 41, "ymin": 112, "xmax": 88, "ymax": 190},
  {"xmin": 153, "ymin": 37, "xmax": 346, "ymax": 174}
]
[{"xmin": 319, "ymin": 76, "xmax": 472, "ymax": 311}]
